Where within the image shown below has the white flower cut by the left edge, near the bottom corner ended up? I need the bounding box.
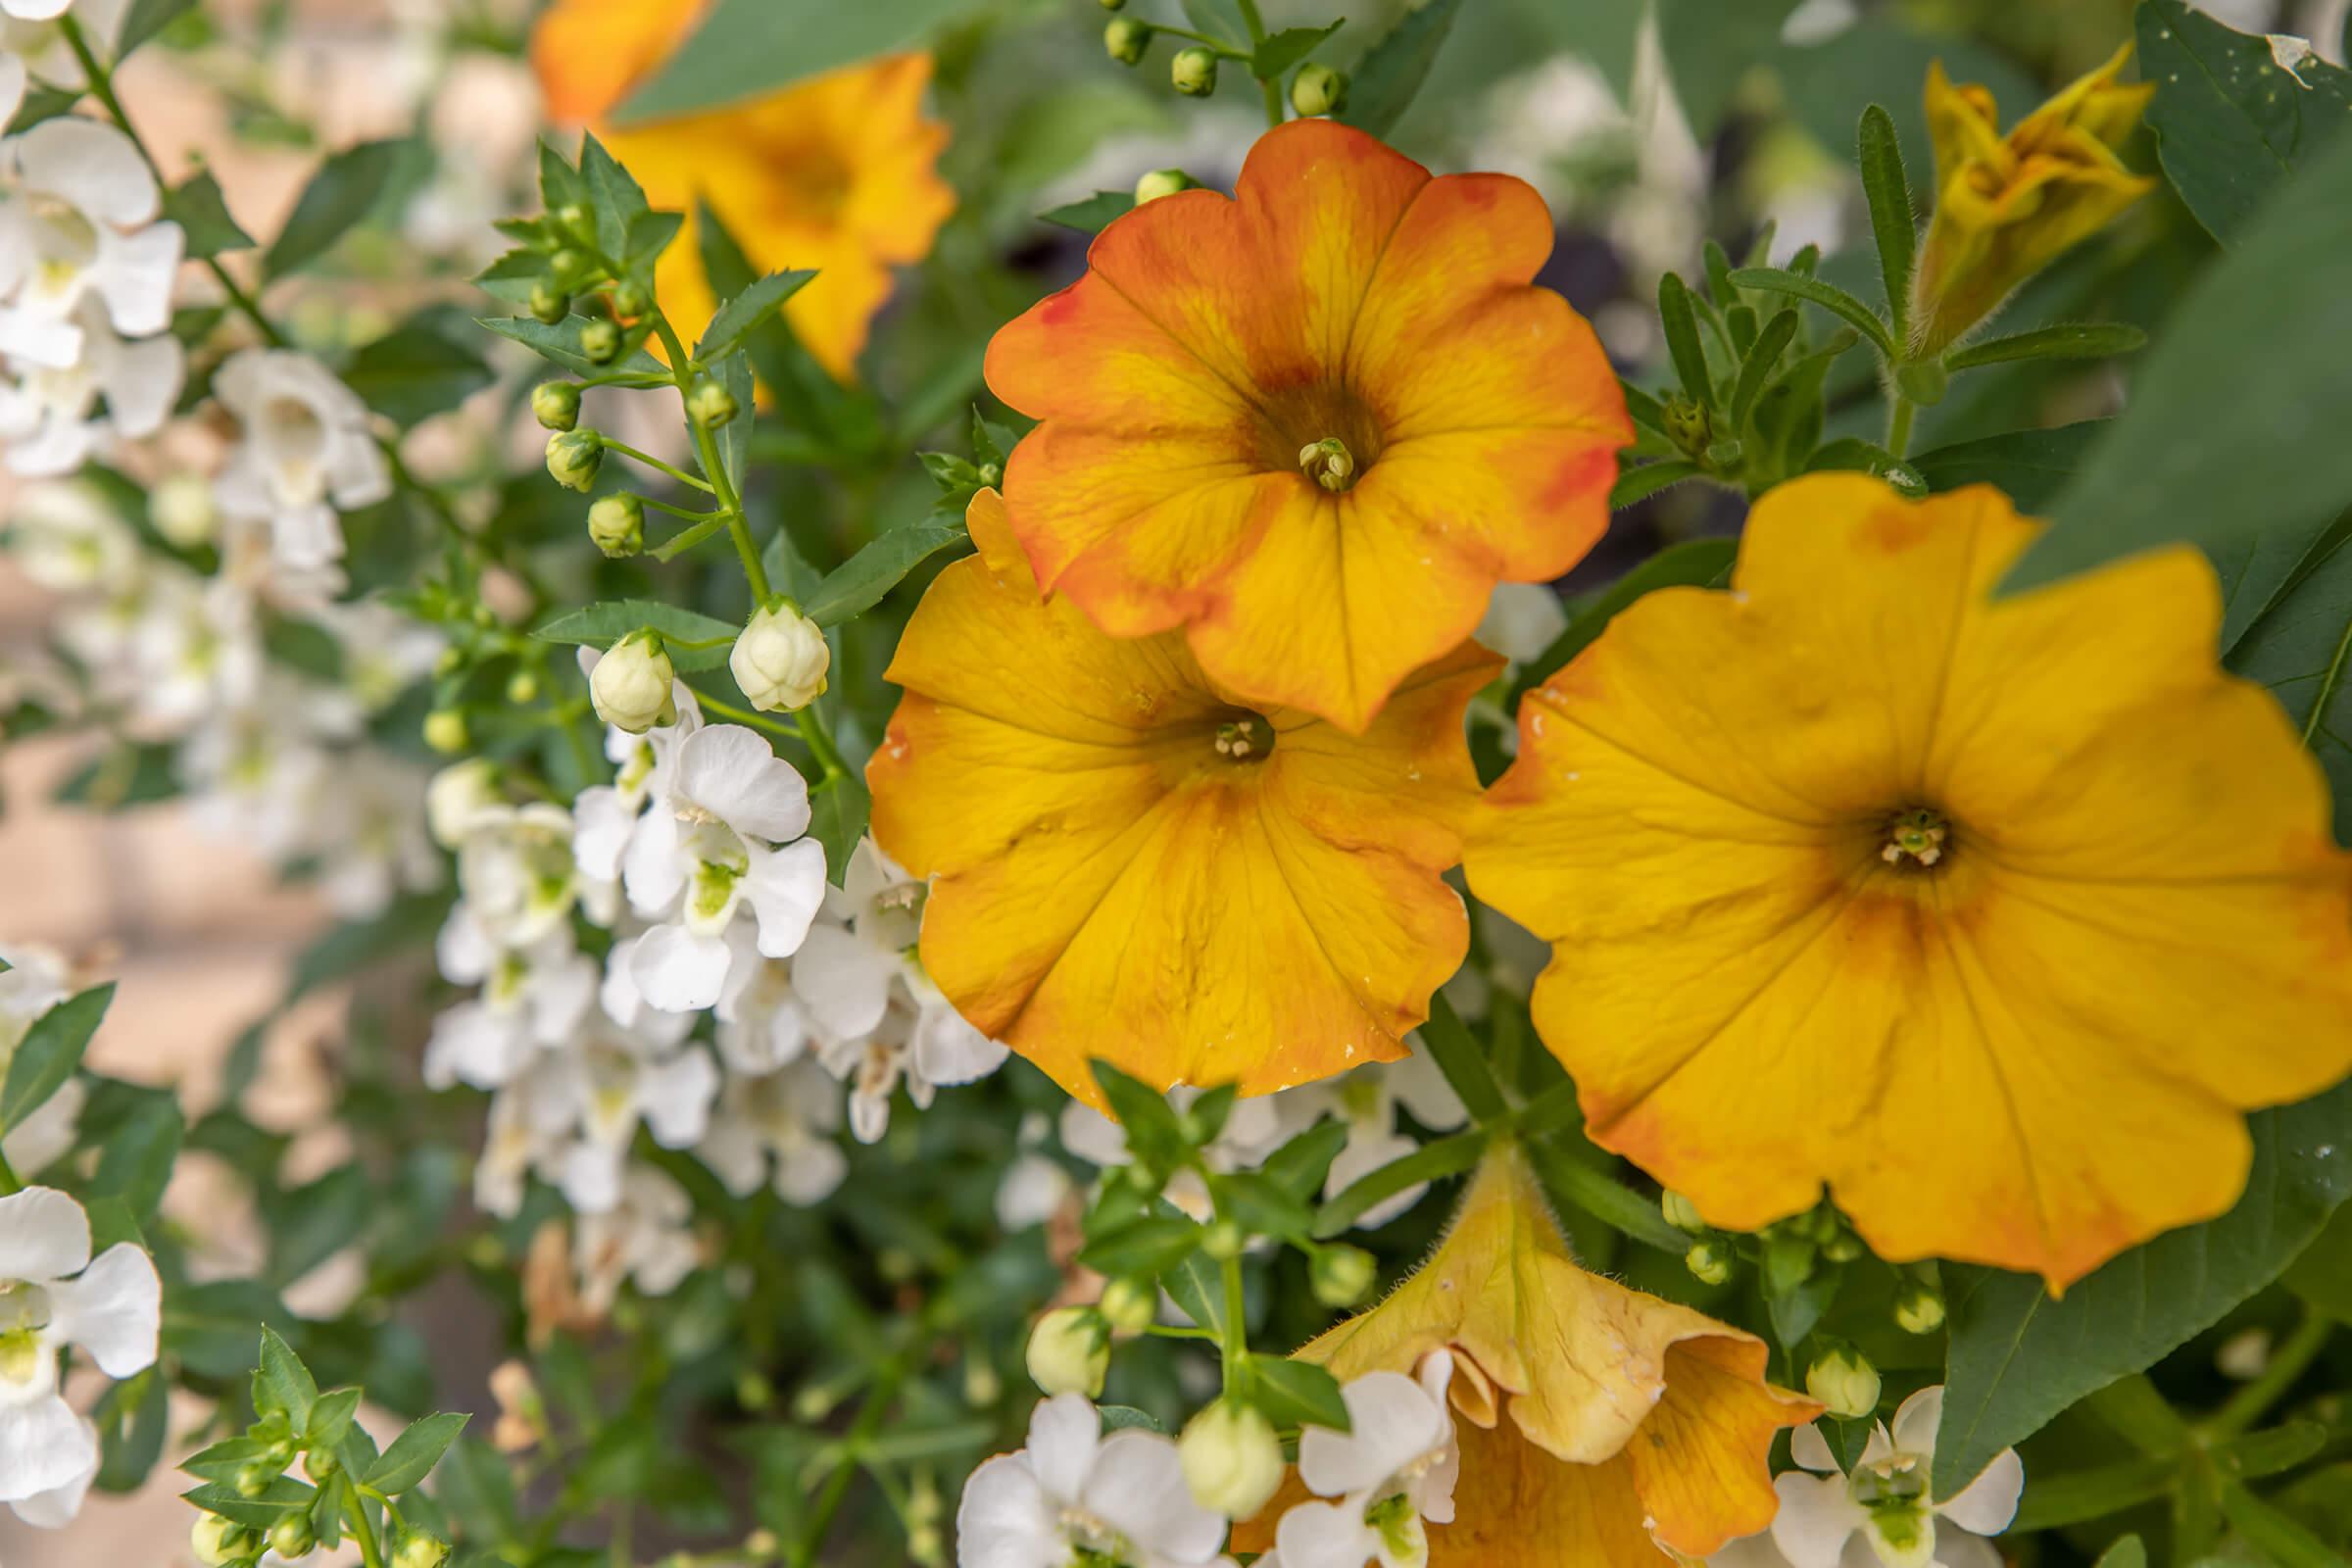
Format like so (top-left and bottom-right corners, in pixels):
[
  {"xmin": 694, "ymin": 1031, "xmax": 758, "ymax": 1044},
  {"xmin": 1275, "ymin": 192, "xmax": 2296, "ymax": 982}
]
[{"xmin": 0, "ymin": 1187, "xmax": 163, "ymax": 1507}]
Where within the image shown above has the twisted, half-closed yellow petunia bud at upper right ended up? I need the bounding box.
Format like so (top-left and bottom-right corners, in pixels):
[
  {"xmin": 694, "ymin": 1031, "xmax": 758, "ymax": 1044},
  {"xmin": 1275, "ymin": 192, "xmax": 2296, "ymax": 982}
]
[{"xmin": 1910, "ymin": 45, "xmax": 2157, "ymax": 360}]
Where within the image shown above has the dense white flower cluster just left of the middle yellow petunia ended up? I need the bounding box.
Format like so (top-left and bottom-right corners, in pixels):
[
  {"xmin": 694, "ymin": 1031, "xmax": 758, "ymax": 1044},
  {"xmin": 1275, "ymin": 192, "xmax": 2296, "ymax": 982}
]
[{"xmin": 425, "ymin": 676, "xmax": 1006, "ymax": 1293}]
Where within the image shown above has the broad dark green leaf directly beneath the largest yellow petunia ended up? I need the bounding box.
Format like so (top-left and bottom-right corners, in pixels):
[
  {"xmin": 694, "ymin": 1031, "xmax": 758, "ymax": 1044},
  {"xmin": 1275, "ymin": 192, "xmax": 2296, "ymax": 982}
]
[{"xmin": 1931, "ymin": 1084, "xmax": 2352, "ymax": 1497}]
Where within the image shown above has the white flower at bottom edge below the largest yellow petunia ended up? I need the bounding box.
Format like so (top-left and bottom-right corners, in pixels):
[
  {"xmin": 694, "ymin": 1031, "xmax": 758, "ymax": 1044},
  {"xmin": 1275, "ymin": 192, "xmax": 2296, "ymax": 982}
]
[{"xmin": 1771, "ymin": 1385, "xmax": 2025, "ymax": 1568}]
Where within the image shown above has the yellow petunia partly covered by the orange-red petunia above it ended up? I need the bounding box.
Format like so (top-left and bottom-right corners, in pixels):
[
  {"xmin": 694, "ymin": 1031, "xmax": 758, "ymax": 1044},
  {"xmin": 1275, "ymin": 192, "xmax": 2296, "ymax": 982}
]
[{"xmin": 865, "ymin": 491, "xmax": 1500, "ymax": 1107}]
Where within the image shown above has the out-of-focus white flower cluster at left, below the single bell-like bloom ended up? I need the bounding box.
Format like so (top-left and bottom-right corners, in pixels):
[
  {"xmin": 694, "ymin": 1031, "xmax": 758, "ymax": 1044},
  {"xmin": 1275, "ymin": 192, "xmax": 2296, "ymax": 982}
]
[{"xmin": 7, "ymin": 479, "xmax": 442, "ymax": 919}]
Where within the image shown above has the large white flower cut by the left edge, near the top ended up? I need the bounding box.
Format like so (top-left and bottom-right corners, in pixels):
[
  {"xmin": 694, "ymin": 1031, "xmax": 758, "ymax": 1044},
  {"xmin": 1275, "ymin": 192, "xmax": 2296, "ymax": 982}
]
[{"xmin": 0, "ymin": 116, "xmax": 186, "ymax": 369}]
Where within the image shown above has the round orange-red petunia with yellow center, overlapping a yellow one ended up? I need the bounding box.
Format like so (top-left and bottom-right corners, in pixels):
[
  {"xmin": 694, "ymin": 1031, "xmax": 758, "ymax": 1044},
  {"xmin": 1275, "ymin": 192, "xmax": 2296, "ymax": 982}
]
[{"xmin": 988, "ymin": 120, "xmax": 1633, "ymax": 731}]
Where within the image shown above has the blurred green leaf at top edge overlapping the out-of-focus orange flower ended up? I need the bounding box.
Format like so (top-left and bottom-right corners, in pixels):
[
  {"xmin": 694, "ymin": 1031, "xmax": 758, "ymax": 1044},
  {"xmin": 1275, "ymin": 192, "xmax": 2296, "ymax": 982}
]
[{"xmin": 613, "ymin": 0, "xmax": 974, "ymax": 124}]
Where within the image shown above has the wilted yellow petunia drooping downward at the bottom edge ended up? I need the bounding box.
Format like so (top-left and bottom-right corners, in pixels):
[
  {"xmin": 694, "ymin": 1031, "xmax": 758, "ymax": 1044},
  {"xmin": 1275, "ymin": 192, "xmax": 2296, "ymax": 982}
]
[{"xmin": 1233, "ymin": 1143, "xmax": 1821, "ymax": 1568}]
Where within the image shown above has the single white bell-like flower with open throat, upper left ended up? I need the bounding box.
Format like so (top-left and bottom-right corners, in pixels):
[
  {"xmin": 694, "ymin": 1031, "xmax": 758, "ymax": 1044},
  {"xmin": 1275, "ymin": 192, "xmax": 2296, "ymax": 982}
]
[{"xmin": 212, "ymin": 348, "xmax": 393, "ymax": 569}]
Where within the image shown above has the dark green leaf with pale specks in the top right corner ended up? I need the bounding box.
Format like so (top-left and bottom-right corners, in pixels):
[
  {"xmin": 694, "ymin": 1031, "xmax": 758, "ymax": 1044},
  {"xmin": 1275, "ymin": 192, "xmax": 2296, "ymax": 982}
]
[{"xmin": 2133, "ymin": 0, "xmax": 2352, "ymax": 244}]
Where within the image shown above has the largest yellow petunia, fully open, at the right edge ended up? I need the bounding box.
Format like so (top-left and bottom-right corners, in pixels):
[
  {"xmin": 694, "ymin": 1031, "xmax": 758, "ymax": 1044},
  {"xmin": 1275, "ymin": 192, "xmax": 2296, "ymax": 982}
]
[{"xmin": 1465, "ymin": 475, "xmax": 2352, "ymax": 1286}]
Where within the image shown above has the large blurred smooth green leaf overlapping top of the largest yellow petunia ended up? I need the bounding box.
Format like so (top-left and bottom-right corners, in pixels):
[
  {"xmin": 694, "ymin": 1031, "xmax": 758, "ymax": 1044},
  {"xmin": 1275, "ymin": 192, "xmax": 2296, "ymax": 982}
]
[{"xmin": 2004, "ymin": 136, "xmax": 2352, "ymax": 592}]
